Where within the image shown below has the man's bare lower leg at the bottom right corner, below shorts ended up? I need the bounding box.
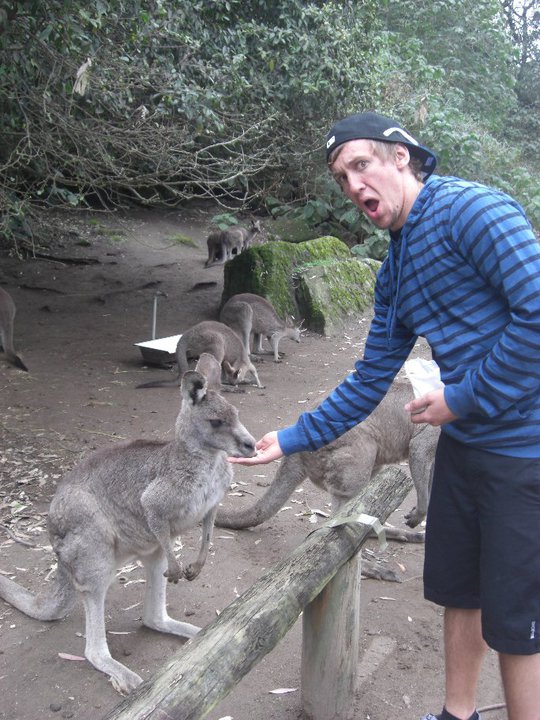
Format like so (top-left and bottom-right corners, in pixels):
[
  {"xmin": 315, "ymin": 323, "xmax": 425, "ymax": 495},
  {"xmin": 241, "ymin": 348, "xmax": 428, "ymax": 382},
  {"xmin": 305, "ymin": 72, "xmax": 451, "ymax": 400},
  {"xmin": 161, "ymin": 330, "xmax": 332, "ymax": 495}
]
[{"xmin": 499, "ymin": 653, "xmax": 540, "ymax": 720}]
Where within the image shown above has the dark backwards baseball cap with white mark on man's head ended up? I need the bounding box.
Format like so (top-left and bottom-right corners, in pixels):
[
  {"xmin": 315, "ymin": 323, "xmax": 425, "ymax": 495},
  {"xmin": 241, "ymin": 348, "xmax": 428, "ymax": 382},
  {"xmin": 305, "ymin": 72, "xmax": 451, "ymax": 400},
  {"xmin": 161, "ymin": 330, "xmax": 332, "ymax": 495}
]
[{"xmin": 326, "ymin": 112, "xmax": 437, "ymax": 180}]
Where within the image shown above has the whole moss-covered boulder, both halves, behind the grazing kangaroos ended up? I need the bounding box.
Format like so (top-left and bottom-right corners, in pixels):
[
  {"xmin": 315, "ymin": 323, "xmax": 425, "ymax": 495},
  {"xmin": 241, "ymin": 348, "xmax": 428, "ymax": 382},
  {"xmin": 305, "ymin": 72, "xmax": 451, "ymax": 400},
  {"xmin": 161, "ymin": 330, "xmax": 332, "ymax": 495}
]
[{"xmin": 222, "ymin": 237, "xmax": 380, "ymax": 335}]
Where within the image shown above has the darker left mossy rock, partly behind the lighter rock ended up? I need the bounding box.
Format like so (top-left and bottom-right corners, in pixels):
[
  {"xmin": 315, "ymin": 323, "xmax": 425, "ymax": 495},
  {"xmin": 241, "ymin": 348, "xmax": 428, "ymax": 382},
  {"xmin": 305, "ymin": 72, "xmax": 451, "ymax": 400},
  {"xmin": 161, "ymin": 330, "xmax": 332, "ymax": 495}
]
[{"xmin": 221, "ymin": 237, "xmax": 352, "ymax": 318}]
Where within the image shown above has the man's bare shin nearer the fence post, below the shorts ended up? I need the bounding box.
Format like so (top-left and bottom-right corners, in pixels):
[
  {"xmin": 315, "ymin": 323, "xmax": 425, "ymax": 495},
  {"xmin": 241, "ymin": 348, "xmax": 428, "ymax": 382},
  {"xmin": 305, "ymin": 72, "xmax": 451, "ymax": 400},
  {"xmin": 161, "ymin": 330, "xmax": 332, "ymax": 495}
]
[{"xmin": 444, "ymin": 608, "xmax": 488, "ymax": 720}]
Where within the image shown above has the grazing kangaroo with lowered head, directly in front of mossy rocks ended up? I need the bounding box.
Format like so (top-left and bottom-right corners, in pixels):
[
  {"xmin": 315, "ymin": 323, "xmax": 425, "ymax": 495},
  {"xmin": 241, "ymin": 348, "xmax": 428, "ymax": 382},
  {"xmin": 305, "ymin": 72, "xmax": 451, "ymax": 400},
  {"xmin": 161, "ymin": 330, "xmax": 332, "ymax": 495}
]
[{"xmin": 219, "ymin": 293, "xmax": 302, "ymax": 362}]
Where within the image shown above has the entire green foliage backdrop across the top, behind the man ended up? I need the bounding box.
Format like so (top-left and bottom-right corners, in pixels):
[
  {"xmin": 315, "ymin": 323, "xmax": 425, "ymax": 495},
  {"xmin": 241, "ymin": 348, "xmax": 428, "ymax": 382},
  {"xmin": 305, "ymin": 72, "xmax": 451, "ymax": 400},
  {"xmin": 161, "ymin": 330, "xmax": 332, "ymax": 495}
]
[{"xmin": 0, "ymin": 0, "xmax": 540, "ymax": 257}]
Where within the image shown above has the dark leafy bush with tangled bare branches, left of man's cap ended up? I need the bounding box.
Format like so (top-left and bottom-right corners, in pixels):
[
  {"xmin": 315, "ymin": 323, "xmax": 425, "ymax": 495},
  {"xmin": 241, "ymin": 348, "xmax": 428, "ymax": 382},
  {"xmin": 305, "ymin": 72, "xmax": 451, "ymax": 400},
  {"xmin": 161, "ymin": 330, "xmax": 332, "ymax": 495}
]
[{"xmin": 0, "ymin": 0, "xmax": 384, "ymax": 252}]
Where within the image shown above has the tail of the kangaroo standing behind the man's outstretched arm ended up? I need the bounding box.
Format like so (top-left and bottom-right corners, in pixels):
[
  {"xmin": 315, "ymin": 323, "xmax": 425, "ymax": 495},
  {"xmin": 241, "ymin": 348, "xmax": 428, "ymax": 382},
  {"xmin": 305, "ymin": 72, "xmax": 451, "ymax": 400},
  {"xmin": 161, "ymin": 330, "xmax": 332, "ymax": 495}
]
[{"xmin": 215, "ymin": 453, "xmax": 306, "ymax": 530}]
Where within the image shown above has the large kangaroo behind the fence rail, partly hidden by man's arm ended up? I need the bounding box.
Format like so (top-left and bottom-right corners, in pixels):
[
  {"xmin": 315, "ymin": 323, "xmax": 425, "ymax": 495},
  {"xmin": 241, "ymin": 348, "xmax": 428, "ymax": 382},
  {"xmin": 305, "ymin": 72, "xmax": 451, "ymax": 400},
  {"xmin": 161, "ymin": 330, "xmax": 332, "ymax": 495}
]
[{"xmin": 216, "ymin": 381, "xmax": 440, "ymax": 579}]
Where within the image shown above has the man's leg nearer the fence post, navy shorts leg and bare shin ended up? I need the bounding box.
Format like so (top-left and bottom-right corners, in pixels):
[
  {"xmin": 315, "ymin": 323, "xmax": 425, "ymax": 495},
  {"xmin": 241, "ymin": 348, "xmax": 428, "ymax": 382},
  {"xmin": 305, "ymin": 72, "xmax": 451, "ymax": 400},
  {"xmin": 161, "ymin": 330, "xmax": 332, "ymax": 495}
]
[{"xmin": 424, "ymin": 433, "xmax": 487, "ymax": 720}]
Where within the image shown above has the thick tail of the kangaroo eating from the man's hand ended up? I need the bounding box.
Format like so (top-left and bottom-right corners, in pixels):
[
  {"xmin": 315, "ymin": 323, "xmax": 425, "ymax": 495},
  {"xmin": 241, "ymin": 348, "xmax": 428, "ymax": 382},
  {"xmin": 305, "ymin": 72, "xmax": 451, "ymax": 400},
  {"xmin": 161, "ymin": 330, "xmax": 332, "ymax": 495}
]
[{"xmin": 0, "ymin": 564, "xmax": 76, "ymax": 620}]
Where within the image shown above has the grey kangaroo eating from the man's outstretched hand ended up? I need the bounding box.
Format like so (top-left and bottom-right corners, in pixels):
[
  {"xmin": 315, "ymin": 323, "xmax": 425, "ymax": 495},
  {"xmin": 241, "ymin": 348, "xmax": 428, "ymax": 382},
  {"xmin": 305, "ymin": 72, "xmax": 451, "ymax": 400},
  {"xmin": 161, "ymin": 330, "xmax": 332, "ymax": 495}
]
[{"xmin": 0, "ymin": 357, "xmax": 255, "ymax": 694}]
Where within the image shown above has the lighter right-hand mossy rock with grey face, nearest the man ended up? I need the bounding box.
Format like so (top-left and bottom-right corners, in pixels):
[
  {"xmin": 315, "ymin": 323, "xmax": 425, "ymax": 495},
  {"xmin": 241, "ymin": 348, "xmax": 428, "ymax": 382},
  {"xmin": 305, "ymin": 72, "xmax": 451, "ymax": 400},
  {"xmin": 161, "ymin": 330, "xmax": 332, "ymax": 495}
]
[{"xmin": 295, "ymin": 258, "xmax": 381, "ymax": 335}]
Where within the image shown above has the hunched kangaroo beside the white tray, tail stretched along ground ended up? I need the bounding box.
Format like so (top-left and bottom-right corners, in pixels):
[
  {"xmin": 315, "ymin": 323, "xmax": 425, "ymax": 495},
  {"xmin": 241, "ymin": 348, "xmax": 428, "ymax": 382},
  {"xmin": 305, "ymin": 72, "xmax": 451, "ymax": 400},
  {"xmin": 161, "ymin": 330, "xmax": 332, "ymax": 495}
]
[{"xmin": 137, "ymin": 320, "xmax": 264, "ymax": 388}]
